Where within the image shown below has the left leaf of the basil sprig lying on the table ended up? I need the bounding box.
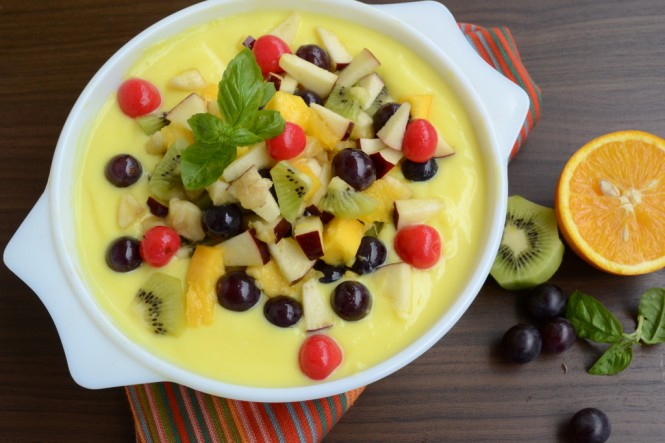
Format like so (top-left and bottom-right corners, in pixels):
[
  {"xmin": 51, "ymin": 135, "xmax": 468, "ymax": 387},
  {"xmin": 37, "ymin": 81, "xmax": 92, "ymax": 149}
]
[{"xmin": 566, "ymin": 291, "xmax": 623, "ymax": 343}]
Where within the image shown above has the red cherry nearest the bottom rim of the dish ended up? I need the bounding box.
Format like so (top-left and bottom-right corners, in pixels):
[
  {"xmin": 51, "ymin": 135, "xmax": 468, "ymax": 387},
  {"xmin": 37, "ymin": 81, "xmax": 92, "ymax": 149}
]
[{"xmin": 298, "ymin": 334, "xmax": 342, "ymax": 380}]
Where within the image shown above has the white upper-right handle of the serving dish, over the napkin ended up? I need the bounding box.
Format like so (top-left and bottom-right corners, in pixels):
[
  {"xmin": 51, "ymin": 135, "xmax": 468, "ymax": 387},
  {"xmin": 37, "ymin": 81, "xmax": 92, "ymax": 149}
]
[{"xmin": 376, "ymin": 0, "xmax": 530, "ymax": 163}]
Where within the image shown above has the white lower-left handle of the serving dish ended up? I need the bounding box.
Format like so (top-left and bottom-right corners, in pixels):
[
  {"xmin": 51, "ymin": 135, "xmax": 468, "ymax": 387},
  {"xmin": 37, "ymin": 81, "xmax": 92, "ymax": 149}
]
[{"xmin": 3, "ymin": 192, "xmax": 163, "ymax": 389}]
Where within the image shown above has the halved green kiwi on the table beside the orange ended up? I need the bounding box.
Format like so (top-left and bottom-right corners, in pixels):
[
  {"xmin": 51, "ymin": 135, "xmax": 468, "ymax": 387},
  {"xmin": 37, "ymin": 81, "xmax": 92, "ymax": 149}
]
[{"xmin": 490, "ymin": 195, "xmax": 564, "ymax": 290}]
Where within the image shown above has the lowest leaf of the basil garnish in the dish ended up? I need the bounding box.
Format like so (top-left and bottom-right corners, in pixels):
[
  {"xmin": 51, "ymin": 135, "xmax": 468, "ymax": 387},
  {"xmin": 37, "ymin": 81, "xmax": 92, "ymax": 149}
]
[{"xmin": 180, "ymin": 142, "xmax": 236, "ymax": 189}]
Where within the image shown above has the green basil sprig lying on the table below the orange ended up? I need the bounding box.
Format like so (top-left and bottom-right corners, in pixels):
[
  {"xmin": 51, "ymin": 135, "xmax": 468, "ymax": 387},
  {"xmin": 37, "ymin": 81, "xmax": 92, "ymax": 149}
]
[{"xmin": 566, "ymin": 288, "xmax": 665, "ymax": 375}]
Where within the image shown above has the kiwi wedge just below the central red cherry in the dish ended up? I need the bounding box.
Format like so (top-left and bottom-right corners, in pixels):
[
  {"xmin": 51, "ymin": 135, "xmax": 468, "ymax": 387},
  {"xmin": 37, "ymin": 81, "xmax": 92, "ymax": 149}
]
[{"xmin": 270, "ymin": 160, "xmax": 312, "ymax": 223}]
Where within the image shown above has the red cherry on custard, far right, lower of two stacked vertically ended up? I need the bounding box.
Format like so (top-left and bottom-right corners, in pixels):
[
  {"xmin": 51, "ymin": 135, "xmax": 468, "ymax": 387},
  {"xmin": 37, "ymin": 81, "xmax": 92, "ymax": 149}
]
[{"xmin": 394, "ymin": 225, "xmax": 441, "ymax": 269}]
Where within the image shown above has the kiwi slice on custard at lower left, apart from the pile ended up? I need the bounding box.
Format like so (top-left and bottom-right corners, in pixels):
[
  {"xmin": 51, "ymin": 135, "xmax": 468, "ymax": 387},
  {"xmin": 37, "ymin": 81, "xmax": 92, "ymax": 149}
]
[{"xmin": 132, "ymin": 272, "xmax": 186, "ymax": 336}]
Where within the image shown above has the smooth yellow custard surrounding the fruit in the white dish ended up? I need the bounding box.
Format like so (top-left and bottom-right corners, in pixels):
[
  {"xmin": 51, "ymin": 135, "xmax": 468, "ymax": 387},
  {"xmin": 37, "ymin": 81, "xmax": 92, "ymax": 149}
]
[{"xmin": 75, "ymin": 8, "xmax": 488, "ymax": 387}]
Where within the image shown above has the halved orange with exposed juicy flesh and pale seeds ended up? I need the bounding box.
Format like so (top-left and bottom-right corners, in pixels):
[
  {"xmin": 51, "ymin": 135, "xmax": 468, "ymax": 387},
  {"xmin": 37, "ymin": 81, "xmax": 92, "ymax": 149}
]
[{"xmin": 555, "ymin": 131, "xmax": 665, "ymax": 275}]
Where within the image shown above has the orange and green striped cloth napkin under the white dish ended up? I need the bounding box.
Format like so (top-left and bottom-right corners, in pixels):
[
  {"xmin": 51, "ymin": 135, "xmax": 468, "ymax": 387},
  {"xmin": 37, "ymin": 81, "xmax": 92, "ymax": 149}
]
[{"xmin": 125, "ymin": 23, "xmax": 542, "ymax": 443}]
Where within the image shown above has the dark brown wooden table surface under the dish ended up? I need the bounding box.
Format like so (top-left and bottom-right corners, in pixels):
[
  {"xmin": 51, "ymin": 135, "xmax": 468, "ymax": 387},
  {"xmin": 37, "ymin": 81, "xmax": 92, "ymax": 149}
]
[{"xmin": 0, "ymin": 0, "xmax": 665, "ymax": 442}]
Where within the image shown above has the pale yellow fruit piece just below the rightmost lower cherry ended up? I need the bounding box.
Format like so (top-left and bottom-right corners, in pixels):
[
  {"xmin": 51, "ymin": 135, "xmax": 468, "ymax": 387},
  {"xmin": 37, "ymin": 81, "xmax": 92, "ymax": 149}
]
[{"xmin": 372, "ymin": 263, "xmax": 414, "ymax": 317}]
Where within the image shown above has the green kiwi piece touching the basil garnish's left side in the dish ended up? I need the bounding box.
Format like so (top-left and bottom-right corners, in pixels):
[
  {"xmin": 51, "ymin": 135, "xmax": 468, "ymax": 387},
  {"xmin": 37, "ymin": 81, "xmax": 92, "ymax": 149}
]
[{"xmin": 148, "ymin": 139, "xmax": 187, "ymax": 202}]
